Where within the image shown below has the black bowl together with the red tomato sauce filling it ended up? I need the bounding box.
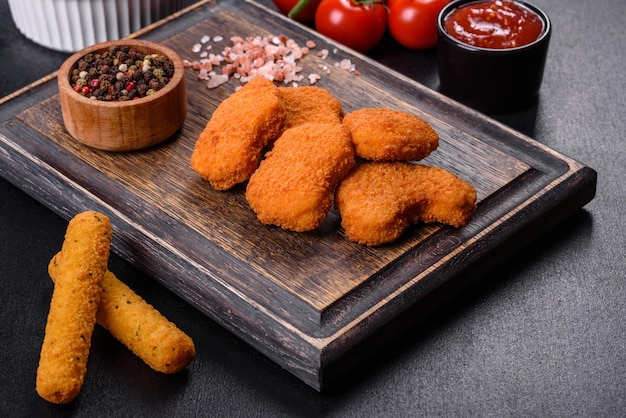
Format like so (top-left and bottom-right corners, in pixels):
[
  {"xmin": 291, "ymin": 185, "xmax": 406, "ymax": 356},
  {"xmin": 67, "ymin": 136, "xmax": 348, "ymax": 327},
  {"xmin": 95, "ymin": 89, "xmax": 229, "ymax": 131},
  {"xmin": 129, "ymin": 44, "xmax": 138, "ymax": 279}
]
[{"xmin": 437, "ymin": 0, "xmax": 552, "ymax": 114}]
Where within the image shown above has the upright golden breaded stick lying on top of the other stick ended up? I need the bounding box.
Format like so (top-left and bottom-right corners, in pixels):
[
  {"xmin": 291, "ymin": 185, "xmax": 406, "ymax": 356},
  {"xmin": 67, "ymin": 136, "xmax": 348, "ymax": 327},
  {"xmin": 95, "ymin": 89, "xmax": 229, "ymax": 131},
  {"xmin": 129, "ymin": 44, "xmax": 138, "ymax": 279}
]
[{"xmin": 36, "ymin": 211, "xmax": 112, "ymax": 403}]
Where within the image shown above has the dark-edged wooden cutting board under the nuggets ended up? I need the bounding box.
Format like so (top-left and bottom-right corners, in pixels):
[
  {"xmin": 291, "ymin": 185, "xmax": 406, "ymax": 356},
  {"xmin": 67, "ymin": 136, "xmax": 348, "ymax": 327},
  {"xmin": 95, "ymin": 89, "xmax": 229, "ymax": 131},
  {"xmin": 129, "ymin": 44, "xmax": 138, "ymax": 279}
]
[{"xmin": 0, "ymin": 1, "xmax": 596, "ymax": 390}]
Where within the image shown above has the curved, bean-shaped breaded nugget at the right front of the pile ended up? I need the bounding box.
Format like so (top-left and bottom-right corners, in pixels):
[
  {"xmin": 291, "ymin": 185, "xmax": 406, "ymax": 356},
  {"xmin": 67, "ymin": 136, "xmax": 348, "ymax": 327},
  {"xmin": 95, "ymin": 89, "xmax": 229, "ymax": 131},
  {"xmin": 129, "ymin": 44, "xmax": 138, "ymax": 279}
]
[{"xmin": 335, "ymin": 161, "xmax": 476, "ymax": 246}]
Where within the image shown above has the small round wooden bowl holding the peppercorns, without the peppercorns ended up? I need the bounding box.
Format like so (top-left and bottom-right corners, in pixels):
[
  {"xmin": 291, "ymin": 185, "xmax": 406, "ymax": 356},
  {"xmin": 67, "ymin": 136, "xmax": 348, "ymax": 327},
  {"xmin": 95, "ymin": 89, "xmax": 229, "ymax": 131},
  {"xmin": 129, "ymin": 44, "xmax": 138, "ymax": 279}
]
[{"xmin": 57, "ymin": 39, "xmax": 187, "ymax": 151}]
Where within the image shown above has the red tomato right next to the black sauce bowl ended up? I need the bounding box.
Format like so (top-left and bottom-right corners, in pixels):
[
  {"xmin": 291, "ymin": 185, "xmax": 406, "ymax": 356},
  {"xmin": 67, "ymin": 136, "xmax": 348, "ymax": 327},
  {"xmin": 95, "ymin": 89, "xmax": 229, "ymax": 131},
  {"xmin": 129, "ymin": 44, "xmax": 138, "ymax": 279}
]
[{"xmin": 387, "ymin": 0, "xmax": 450, "ymax": 49}]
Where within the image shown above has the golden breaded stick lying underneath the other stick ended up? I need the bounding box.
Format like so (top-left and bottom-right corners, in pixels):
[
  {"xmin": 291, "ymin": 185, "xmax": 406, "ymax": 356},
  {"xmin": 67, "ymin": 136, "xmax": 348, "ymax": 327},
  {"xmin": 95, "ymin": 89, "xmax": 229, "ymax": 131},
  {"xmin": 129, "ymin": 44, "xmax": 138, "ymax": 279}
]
[{"xmin": 48, "ymin": 252, "xmax": 195, "ymax": 373}]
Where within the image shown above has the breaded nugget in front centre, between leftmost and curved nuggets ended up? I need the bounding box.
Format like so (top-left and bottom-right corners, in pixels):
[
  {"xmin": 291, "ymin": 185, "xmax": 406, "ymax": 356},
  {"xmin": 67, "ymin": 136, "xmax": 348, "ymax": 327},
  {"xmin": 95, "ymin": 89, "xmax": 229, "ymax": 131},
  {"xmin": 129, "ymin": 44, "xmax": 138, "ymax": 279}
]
[{"xmin": 246, "ymin": 123, "xmax": 355, "ymax": 232}]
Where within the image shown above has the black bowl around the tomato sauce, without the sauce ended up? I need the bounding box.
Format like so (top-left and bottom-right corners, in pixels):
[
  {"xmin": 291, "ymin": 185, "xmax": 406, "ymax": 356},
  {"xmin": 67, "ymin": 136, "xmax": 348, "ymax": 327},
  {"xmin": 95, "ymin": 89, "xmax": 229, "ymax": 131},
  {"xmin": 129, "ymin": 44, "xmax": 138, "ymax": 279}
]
[{"xmin": 437, "ymin": 0, "xmax": 552, "ymax": 114}]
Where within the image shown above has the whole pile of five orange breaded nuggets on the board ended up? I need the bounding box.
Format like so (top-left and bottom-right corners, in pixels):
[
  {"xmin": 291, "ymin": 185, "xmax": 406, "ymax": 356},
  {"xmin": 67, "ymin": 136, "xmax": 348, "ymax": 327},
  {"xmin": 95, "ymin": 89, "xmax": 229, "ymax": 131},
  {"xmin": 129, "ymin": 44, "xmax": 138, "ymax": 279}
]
[{"xmin": 191, "ymin": 77, "xmax": 476, "ymax": 246}]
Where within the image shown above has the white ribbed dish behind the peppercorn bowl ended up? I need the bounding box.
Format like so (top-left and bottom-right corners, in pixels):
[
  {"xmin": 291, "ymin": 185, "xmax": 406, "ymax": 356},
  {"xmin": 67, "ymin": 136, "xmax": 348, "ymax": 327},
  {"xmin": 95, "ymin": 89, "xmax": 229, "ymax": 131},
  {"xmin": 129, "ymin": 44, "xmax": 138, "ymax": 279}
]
[{"xmin": 8, "ymin": 0, "xmax": 183, "ymax": 52}]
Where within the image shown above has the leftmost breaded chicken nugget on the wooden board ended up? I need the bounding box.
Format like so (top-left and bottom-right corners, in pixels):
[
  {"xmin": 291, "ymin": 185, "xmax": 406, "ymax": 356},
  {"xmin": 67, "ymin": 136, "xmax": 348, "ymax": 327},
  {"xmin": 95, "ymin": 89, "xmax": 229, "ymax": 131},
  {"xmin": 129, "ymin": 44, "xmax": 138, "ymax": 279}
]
[{"xmin": 191, "ymin": 77, "xmax": 284, "ymax": 190}]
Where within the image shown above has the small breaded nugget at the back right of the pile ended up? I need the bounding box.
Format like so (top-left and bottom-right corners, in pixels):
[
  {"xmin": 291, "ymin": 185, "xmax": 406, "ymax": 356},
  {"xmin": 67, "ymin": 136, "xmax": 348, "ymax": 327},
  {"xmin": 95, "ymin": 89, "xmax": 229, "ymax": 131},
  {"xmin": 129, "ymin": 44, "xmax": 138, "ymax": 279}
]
[{"xmin": 343, "ymin": 108, "xmax": 439, "ymax": 161}]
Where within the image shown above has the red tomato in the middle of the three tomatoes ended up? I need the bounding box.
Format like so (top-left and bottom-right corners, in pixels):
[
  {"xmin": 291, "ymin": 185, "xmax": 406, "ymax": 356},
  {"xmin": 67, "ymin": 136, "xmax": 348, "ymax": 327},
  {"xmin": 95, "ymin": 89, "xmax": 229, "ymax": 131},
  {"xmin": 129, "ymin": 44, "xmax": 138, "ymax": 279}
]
[{"xmin": 315, "ymin": 0, "xmax": 387, "ymax": 52}]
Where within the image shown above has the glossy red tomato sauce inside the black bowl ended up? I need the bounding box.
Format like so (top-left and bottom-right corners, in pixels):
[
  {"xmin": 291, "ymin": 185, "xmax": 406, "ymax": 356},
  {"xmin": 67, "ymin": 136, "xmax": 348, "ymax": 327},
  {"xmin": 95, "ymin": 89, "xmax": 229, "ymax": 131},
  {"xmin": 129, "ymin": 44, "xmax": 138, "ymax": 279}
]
[{"xmin": 444, "ymin": 0, "xmax": 544, "ymax": 49}]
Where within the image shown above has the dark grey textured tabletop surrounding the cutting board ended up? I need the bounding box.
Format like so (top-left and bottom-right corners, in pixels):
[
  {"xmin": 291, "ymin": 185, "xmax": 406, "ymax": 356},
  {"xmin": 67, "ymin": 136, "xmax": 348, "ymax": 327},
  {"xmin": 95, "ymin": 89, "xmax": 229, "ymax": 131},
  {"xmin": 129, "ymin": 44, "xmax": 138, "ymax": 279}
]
[{"xmin": 0, "ymin": 0, "xmax": 626, "ymax": 417}]
